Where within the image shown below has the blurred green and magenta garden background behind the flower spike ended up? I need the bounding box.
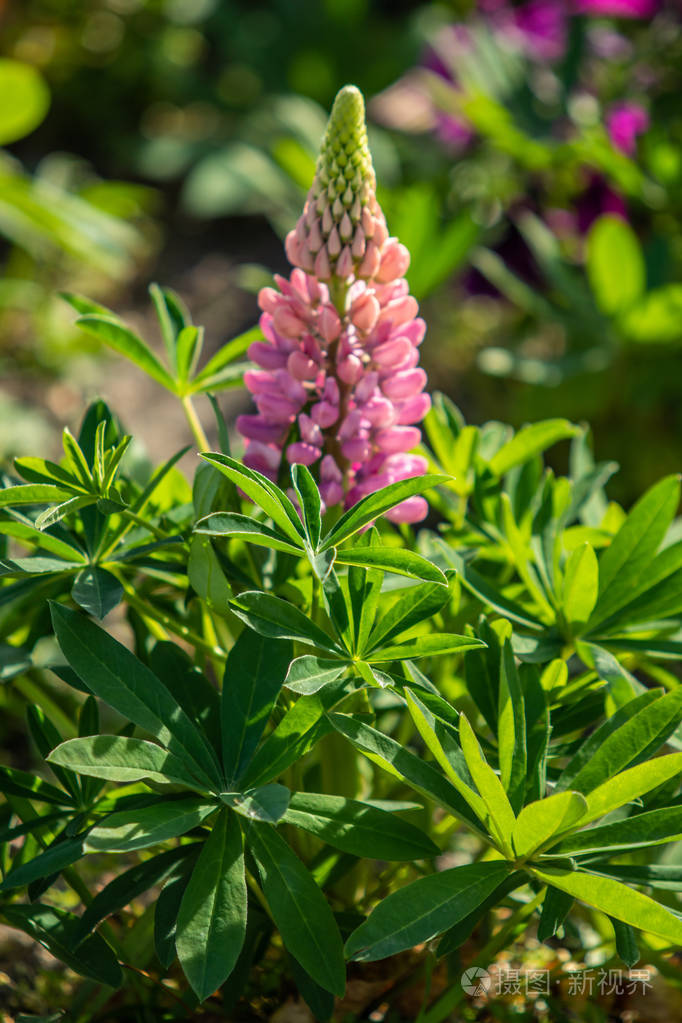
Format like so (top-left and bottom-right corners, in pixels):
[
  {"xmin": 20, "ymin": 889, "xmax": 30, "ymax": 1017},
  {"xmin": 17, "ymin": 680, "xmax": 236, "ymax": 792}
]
[{"xmin": 0, "ymin": 0, "xmax": 682, "ymax": 501}]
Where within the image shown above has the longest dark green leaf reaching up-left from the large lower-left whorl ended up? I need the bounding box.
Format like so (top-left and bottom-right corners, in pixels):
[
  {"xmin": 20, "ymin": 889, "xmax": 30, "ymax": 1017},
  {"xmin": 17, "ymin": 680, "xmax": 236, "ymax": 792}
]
[{"xmin": 51, "ymin": 604, "xmax": 220, "ymax": 786}]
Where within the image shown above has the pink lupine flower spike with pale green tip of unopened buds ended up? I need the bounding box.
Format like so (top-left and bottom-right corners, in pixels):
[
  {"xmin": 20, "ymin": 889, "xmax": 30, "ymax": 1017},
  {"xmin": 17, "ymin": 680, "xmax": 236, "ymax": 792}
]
[{"xmin": 237, "ymin": 86, "xmax": 430, "ymax": 522}]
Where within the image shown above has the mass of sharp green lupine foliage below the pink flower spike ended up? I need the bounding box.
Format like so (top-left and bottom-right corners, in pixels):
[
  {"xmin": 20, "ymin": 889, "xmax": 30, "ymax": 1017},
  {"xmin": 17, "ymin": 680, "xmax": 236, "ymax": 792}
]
[{"xmin": 0, "ymin": 292, "xmax": 682, "ymax": 1023}]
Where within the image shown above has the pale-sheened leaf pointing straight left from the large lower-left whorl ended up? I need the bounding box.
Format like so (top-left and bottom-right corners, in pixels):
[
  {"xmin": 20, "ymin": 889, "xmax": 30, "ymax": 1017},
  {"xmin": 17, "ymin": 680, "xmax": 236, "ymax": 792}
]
[{"xmin": 47, "ymin": 736, "xmax": 205, "ymax": 790}]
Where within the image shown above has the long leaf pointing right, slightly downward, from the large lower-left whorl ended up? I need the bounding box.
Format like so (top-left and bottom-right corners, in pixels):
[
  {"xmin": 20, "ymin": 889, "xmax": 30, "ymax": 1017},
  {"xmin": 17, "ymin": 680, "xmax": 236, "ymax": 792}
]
[{"xmin": 284, "ymin": 792, "xmax": 439, "ymax": 860}]
